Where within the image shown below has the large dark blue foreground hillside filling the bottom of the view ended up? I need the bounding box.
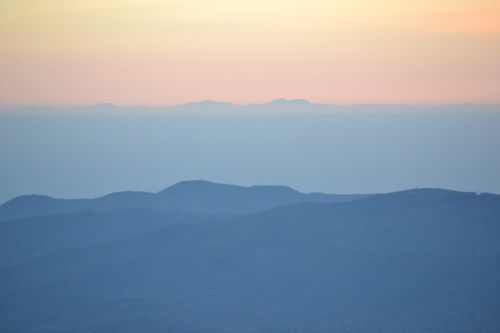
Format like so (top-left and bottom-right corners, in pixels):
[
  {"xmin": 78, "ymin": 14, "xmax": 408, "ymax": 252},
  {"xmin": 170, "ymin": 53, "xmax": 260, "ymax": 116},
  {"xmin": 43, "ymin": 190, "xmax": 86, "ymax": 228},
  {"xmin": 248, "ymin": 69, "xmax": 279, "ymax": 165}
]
[{"xmin": 0, "ymin": 185, "xmax": 500, "ymax": 333}]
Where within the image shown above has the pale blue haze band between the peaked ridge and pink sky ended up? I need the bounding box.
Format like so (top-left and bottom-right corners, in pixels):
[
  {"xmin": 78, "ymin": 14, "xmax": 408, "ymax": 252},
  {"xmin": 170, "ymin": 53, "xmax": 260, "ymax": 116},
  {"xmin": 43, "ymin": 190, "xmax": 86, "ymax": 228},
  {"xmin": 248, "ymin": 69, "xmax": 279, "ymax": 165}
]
[{"xmin": 0, "ymin": 106, "xmax": 500, "ymax": 203}]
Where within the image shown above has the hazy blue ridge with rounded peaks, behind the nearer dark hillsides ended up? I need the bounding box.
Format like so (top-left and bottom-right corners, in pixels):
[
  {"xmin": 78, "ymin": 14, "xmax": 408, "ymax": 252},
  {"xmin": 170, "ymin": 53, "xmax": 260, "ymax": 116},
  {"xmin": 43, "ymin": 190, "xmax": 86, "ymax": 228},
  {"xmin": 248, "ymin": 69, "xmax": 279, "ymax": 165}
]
[{"xmin": 0, "ymin": 180, "xmax": 362, "ymax": 222}]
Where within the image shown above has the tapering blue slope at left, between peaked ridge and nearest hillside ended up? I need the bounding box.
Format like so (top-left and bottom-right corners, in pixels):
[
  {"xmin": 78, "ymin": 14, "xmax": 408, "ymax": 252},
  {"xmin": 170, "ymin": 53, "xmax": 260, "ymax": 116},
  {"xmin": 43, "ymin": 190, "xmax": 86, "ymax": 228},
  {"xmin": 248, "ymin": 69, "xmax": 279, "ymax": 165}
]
[{"xmin": 0, "ymin": 209, "xmax": 193, "ymax": 269}]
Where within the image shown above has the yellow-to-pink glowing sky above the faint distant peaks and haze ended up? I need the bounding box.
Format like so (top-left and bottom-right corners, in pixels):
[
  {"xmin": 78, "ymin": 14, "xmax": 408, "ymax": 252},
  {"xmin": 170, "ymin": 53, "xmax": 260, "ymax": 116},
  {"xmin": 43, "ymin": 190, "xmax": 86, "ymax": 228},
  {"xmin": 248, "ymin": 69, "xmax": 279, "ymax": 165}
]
[{"xmin": 0, "ymin": 0, "xmax": 500, "ymax": 105}]
